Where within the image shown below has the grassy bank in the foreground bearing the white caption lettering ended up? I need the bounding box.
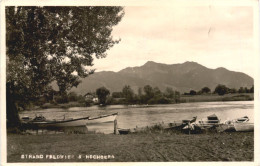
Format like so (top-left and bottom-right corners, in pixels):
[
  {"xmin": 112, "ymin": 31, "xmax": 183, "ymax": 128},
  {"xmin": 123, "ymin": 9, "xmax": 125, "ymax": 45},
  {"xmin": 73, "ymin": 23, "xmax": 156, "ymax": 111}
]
[{"xmin": 7, "ymin": 132, "xmax": 254, "ymax": 162}]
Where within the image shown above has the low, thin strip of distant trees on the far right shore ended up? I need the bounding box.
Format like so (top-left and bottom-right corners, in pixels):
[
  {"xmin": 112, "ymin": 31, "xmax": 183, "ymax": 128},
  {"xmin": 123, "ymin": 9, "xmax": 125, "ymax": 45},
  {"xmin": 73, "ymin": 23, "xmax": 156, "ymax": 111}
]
[{"xmin": 184, "ymin": 84, "xmax": 254, "ymax": 95}]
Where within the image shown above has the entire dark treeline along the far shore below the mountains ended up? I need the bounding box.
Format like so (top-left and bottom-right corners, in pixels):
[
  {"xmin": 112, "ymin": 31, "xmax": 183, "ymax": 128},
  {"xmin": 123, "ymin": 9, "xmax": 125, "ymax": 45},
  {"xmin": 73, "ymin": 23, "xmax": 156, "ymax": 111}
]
[{"xmin": 32, "ymin": 84, "xmax": 254, "ymax": 109}]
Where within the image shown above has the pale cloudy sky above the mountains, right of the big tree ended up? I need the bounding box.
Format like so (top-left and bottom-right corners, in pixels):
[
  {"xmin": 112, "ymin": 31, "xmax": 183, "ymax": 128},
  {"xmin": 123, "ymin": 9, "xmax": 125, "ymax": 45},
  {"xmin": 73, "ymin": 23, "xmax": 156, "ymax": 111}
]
[{"xmin": 94, "ymin": 6, "xmax": 255, "ymax": 77}]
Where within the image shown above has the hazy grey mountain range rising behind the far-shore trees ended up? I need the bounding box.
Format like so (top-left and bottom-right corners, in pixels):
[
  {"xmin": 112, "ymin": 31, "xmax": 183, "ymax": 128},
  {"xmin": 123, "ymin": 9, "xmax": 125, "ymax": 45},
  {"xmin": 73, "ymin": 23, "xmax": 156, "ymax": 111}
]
[{"xmin": 71, "ymin": 61, "xmax": 254, "ymax": 94}]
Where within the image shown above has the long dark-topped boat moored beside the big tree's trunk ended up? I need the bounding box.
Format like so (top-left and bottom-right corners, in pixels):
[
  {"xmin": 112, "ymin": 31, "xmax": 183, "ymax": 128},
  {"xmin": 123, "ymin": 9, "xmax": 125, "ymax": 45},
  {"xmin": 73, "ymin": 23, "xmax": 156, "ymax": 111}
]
[{"xmin": 22, "ymin": 116, "xmax": 89, "ymax": 128}]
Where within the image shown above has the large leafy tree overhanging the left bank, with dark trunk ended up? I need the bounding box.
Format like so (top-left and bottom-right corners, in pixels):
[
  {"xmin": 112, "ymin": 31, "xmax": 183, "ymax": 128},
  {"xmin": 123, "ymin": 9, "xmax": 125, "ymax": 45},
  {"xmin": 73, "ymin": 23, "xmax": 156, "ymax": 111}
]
[{"xmin": 6, "ymin": 6, "xmax": 124, "ymax": 124}]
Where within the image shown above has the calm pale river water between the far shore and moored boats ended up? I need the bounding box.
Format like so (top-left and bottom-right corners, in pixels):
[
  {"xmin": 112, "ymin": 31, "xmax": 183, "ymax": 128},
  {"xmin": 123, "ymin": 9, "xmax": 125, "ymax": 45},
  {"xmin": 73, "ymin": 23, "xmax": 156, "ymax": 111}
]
[{"xmin": 20, "ymin": 101, "xmax": 254, "ymax": 132}]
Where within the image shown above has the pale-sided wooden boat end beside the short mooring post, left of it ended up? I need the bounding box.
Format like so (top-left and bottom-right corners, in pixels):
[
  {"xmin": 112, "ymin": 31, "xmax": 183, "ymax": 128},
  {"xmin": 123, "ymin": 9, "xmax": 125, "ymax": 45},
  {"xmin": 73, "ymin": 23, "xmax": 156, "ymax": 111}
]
[{"xmin": 87, "ymin": 113, "xmax": 118, "ymax": 126}]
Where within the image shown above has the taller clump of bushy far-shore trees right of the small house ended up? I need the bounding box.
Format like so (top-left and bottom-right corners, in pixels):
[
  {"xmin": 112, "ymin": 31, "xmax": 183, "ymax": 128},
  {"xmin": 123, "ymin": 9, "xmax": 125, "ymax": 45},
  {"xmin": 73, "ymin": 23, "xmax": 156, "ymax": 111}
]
[{"xmin": 96, "ymin": 85, "xmax": 180, "ymax": 104}]
